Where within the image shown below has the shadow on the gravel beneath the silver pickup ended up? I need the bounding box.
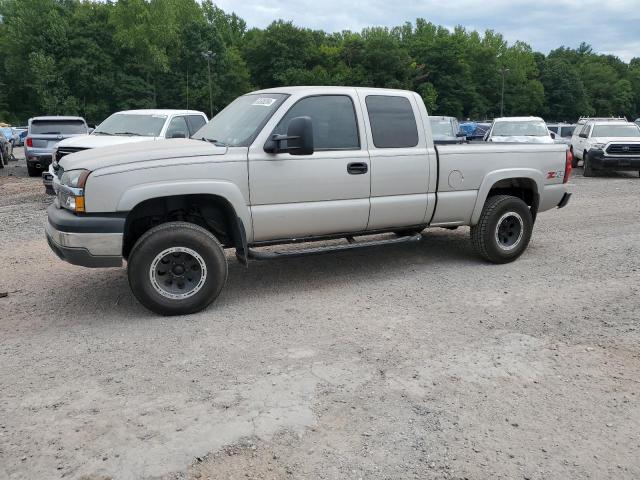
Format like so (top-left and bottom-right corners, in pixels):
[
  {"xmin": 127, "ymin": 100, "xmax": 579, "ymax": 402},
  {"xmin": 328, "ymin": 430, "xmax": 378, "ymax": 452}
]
[{"xmin": 46, "ymin": 228, "xmax": 483, "ymax": 323}]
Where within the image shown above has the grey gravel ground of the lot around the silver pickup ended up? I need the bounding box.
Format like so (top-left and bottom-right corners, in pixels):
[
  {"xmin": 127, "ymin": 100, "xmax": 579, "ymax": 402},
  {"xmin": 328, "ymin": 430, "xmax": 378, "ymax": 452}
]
[{"xmin": 0, "ymin": 148, "xmax": 640, "ymax": 480}]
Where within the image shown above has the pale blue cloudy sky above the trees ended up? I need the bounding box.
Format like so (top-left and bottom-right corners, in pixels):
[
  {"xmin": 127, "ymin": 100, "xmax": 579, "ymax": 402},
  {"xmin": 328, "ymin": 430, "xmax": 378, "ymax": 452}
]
[{"xmin": 214, "ymin": 0, "xmax": 640, "ymax": 61}]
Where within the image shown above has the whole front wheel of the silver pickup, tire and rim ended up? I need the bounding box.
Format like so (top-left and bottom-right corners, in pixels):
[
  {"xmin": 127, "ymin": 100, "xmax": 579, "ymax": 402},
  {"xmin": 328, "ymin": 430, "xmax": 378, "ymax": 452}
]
[{"xmin": 127, "ymin": 222, "xmax": 227, "ymax": 315}]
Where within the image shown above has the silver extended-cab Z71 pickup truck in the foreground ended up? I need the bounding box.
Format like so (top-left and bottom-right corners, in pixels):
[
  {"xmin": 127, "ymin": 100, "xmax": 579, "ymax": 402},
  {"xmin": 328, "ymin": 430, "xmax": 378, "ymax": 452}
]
[{"xmin": 46, "ymin": 87, "xmax": 572, "ymax": 315}]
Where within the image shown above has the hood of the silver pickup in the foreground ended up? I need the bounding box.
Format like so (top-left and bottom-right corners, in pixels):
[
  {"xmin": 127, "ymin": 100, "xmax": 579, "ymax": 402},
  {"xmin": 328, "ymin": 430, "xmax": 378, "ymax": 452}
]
[{"xmin": 60, "ymin": 138, "xmax": 227, "ymax": 171}]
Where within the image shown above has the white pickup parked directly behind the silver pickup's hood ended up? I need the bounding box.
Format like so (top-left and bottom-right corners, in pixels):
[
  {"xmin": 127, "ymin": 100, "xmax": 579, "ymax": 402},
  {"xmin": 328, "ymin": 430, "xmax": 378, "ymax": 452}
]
[{"xmin": 42, "ymin": 109, "xmax": 208, "ymax": 194}]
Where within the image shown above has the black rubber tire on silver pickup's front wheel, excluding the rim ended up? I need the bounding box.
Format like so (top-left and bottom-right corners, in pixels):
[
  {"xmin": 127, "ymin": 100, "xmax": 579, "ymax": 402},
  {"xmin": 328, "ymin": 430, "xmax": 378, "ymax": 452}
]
[{"xmin": 127, "ymin": 222, "xmax": 228, "ymax": 315}]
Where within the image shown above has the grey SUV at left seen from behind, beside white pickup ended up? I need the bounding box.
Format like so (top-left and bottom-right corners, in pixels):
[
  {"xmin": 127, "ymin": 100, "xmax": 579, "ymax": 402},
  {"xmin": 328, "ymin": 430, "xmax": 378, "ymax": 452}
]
[{"xmin": 24, "ymin": 116, "xmax": 87, "ymax": 177}]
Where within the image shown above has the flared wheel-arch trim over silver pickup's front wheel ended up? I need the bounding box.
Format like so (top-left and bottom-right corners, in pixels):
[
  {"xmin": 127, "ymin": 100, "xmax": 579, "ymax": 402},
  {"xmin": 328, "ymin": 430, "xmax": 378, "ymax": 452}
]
[{"xmin": 117, "ymin": 180, "xmax": 253, "ymax": 240}]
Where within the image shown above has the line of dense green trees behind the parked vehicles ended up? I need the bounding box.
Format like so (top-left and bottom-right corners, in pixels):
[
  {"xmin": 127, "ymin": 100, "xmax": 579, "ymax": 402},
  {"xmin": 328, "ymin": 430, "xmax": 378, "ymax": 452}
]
[{"xmin": 0, "ymin": 0, "xmax": 640, "ymax": 124}]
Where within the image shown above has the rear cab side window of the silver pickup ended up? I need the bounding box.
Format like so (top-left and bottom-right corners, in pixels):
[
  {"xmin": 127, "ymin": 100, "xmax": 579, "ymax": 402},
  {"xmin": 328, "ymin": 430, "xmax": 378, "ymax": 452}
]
[{"xmin": 365, "ymin": 95, "xmax": 419, "ymax": 148}]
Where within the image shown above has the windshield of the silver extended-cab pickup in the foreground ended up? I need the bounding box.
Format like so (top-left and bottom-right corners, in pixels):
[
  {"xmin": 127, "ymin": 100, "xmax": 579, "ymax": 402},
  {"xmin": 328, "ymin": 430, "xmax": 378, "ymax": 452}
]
[{"xmin": 192, "ymin": 93, "xmax": 287, "ymax": 147}]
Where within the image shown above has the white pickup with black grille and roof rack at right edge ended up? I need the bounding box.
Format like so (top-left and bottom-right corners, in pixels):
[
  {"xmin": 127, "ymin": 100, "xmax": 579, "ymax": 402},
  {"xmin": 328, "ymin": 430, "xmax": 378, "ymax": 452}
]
[{"xmin": 571, "ymin": 118, "xmax": 640, "ymax": 177}]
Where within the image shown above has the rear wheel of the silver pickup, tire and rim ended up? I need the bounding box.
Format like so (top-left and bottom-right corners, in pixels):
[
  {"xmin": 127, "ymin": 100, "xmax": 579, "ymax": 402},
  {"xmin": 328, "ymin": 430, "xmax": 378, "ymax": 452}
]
[{"xmin": 471, "ymin": 195, "xmax": 533, "ymax": 263}]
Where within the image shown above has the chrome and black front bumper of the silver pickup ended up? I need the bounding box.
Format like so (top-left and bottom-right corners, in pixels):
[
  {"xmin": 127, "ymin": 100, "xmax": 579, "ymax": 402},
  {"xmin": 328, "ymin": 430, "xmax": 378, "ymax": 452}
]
[{"xmin": 45, "ymin": 205, "xmax": 125, "ymax": 268}]
